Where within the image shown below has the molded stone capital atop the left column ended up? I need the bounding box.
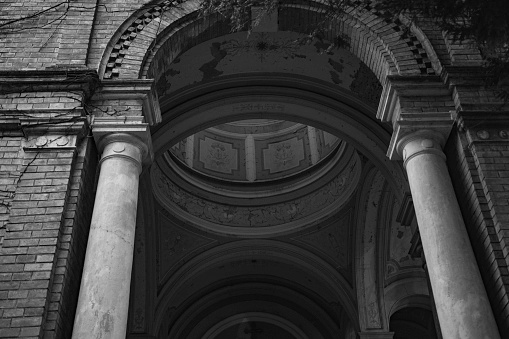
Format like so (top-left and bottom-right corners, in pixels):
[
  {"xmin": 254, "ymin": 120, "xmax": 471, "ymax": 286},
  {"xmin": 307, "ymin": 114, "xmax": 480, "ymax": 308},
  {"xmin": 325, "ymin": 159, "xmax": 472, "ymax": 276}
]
[{"xmin": 92, "ymin": 117, "xmax": 154, "ymax": 166}]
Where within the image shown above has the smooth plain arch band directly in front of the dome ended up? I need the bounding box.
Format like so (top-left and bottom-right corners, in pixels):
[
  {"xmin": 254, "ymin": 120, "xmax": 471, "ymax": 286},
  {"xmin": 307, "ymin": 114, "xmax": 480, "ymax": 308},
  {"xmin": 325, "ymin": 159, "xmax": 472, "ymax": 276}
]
[{"xmin": 153, "ymin": 75, "xmax": 408, "ymax": 195}]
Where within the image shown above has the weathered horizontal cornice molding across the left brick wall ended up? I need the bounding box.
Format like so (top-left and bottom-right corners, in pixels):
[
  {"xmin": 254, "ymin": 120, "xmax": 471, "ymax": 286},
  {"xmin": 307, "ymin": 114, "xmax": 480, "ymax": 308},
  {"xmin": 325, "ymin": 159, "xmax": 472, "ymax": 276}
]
[{"xmin": 0, "ymin": 70, "xmax": 95, "ymax": 146}]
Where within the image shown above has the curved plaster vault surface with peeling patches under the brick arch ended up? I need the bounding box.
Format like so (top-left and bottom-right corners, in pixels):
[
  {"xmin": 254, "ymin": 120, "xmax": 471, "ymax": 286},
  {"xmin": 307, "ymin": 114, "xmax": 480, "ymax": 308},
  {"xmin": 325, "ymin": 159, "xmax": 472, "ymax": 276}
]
[{"xmin": 153, "ymin": 31, "xmax": 381, "ymax": 102}]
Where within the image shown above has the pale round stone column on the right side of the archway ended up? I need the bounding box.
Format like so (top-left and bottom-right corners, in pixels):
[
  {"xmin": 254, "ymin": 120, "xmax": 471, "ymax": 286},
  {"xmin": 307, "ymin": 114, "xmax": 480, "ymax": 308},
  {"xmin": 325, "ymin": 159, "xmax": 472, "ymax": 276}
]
[{"xmin": 396, "ymin": 130, "xmax": 500, "ymax": 339}]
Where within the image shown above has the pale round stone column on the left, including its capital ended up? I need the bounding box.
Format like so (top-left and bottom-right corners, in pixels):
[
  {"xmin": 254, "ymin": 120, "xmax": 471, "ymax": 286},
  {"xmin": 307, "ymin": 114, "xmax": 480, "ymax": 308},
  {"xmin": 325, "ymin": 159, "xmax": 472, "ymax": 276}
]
[{"xmin": 72, "ymin": 124, "xmax": 150, "ymax": 339}]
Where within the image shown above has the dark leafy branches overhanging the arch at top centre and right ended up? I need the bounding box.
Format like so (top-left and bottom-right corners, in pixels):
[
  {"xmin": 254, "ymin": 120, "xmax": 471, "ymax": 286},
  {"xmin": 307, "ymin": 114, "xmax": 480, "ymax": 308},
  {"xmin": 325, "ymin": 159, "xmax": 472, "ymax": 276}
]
[{"xmin": 201, "ymin": 0, "xmax": 509, "ymax": 91}]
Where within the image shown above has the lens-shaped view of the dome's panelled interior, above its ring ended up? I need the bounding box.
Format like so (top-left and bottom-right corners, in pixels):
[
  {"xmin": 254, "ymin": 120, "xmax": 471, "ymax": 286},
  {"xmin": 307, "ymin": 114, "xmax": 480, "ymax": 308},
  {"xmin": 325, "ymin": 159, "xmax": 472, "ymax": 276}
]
[{"xmin": 169, "ymin": 119, "xmax": 341, "ymax": 183}]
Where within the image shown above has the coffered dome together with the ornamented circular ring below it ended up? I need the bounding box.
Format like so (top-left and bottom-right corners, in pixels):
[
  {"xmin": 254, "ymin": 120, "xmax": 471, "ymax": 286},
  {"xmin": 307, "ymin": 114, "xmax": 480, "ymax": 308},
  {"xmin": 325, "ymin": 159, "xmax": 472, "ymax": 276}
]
[{"xmin": 152, "ymin": 119, "xmax": 361, "ymax": 237}]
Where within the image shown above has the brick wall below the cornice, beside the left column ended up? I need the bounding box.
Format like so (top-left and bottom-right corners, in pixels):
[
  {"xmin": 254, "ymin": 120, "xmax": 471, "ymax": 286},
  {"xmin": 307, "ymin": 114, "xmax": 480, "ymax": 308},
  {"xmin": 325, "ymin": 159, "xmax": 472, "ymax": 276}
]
[{"xmin": 0, "ymin": 131, "xmax": 97, "ymax": 338}]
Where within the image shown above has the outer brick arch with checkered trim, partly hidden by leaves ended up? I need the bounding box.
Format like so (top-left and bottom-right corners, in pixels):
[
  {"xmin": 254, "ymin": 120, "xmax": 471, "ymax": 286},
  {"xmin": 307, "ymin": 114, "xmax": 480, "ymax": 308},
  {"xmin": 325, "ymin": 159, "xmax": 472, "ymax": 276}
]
[{"xmin": 99, "ymin": 0, "xmax": 441, "ymax": 84}]
